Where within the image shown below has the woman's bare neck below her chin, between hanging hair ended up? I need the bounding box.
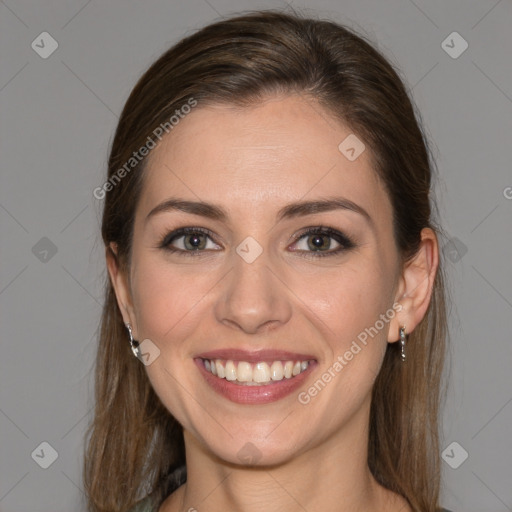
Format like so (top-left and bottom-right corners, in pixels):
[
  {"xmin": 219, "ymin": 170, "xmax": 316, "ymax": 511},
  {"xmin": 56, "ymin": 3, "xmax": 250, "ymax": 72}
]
[{"xmin": 161, "ymin": 398, "xmax": 410, "ymax": 512}]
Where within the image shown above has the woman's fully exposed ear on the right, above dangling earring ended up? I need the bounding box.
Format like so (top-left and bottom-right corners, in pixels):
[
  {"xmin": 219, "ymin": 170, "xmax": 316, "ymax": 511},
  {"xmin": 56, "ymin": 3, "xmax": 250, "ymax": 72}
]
[{"xmin": 388, "ymin": 228, "xmax": 439, "ymax": 343}]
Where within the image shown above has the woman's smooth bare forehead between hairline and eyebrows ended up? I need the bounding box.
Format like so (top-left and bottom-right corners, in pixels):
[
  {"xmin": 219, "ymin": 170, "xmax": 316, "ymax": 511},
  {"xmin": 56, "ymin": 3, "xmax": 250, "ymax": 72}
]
[{"xmin": 138, "ymin": 96, "xmax": 391, "ymax": 230}]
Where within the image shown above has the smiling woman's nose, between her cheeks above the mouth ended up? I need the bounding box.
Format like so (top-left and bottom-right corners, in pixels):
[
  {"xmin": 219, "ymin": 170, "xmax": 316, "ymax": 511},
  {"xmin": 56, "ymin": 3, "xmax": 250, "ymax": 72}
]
[{"xmin": 215, "ymin": 251, "xmax": 292, "ymax": 334}]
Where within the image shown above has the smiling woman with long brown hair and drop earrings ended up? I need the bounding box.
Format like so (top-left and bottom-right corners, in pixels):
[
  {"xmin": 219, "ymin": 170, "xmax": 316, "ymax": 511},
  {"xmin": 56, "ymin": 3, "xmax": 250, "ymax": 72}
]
[{"xmin": 84, "ymin": 11, "xmax": 452, "ymax": 512}]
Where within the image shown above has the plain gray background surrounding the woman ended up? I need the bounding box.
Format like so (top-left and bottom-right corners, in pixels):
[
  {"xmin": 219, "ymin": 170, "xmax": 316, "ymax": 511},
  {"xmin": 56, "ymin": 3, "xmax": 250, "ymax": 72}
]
[{"xmin": 0, "ymin": 0, "xmax": 512, "ymax": 512}]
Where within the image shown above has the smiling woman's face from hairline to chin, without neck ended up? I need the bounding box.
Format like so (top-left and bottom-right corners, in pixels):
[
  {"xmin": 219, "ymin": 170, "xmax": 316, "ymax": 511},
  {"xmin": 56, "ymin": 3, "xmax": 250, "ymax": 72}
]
[{"xmin": 110, "ymin": 96, "xmax": 406, "ymax": 464}]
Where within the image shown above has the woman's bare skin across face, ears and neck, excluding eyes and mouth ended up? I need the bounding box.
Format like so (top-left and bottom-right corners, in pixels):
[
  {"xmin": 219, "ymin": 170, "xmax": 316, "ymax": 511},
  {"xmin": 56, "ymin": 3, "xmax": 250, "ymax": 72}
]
[{"xmin": 107, "ymin": 95, "xmax": 438, "ymax": 512}]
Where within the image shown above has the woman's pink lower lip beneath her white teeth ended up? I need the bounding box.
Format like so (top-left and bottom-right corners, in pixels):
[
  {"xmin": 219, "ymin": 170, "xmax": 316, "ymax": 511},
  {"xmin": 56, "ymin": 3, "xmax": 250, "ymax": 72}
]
[{"xmin": 195, "ymin": 359, "xmax": 316, "ymax": 405}]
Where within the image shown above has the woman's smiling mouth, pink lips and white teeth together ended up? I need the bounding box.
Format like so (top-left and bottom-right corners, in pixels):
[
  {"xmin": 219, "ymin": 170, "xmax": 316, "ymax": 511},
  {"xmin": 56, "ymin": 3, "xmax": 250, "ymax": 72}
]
[{"xmin": 194, "ymin": 350, "xmax": 317, "ymax": 404}]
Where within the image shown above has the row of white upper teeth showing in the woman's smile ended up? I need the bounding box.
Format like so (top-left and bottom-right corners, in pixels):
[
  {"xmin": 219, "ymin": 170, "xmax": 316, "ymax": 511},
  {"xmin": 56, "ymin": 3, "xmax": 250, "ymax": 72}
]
[{"xmin": 203, "ymin": 359, "xmax": 309, "ymax": 386}]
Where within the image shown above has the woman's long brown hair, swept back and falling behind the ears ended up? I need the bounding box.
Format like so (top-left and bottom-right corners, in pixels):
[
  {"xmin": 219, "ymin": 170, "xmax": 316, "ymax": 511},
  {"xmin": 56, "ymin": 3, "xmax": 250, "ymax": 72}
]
[{"xmin": 84, "ymin": 11, "xmax": 447, "ymax": 512}]
